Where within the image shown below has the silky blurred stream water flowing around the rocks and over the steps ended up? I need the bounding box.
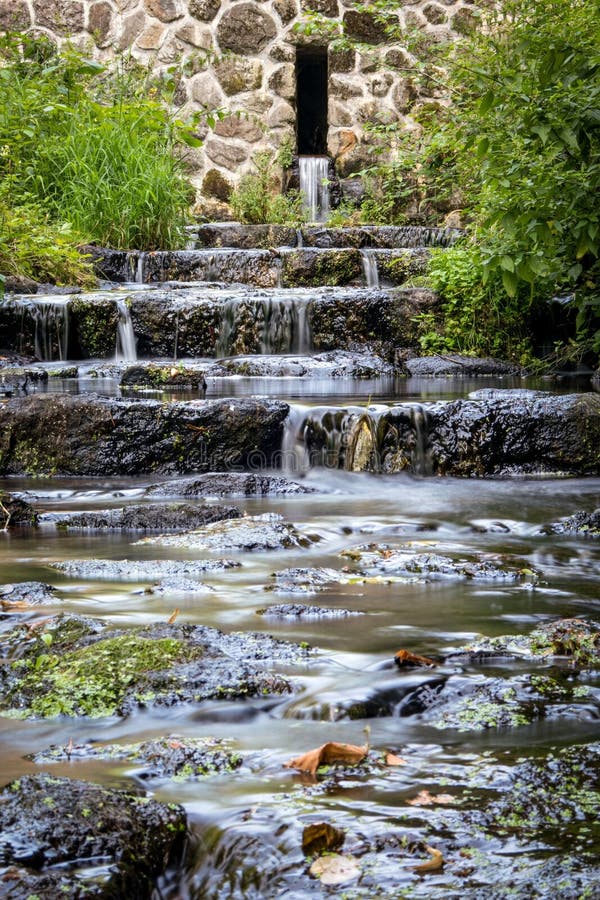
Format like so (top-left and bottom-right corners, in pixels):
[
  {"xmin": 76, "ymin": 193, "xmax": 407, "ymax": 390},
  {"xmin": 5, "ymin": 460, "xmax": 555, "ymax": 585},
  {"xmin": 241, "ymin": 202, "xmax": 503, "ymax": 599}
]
[{"xmin": 0, "ymin": 227, "xmax": 600, "ymax": 900}]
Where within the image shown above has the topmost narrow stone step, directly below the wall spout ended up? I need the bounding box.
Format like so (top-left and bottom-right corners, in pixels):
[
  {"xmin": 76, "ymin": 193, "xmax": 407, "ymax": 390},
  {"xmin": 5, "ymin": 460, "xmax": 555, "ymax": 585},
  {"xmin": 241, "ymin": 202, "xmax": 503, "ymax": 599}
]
[{"xmin": 188, "ymin": 222, "xmax": 462, "ymax": 250}]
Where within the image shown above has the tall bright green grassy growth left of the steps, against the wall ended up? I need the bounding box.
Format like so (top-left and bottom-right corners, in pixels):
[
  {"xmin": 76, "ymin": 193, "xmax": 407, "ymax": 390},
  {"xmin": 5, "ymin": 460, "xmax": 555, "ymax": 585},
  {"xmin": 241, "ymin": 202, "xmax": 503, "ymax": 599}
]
[{"xmin": 0, "ymin": 35, "xmax": 198, "ymax": 250}]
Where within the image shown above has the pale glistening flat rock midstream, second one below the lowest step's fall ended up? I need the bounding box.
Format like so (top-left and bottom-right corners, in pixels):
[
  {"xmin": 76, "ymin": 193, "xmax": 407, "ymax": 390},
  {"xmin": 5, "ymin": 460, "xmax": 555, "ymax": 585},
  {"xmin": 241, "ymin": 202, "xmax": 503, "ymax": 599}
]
[{"xmin": 144, "ymin": 513, "xmax": 315, "ymax": 551}]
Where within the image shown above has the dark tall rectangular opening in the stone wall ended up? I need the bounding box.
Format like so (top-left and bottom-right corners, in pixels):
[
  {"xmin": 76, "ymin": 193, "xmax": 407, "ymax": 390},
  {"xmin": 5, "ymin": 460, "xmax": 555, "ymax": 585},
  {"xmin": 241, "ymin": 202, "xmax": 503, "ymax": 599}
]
[{"xmin": 296, "ymin": 47, "xmax": 327, "ymax": 156}]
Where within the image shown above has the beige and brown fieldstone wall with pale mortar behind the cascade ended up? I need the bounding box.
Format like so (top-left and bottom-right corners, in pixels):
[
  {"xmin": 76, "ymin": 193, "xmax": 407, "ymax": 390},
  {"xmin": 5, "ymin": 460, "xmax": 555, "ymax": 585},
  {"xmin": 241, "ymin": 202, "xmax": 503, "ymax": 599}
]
[{"xmin": 0, "ymin": 0, "xmax": 477, "ymax": 203}]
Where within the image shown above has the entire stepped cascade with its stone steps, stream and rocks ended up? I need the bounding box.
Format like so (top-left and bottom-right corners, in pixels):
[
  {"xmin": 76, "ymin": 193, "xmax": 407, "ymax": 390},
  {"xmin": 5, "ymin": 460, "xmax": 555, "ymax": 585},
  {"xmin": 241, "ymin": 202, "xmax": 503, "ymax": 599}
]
[{"xmin": 0, "ymin": 221, "xmax": 600, "ymax": 900}]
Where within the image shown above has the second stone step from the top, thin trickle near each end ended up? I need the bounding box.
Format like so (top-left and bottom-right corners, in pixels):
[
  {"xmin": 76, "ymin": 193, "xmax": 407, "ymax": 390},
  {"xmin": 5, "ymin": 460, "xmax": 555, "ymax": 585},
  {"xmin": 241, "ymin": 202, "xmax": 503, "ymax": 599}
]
[{"xmin": 90, "ymin": 247, "xmax": 428, "ymax": 288}]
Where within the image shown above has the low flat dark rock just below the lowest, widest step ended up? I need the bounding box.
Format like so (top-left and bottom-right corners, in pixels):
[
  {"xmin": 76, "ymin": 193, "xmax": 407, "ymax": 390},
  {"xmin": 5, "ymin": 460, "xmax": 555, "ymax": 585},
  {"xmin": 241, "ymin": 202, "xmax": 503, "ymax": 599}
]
[{"xmin": 146, "ymin": 472, "xmax": 316, "ymax": 497}]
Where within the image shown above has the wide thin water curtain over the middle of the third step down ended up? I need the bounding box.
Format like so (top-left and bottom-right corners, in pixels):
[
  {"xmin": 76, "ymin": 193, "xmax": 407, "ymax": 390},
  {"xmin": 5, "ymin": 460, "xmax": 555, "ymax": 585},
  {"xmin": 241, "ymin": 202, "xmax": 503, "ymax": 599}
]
[{"xmin": 215, "ymin": 294, "xmax": 312, "ymax": 358}]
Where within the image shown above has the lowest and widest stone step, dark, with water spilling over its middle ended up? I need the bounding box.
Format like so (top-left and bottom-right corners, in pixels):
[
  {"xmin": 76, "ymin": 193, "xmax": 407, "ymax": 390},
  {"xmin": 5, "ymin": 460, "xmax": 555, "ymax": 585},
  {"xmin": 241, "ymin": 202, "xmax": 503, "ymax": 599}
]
[{"xmin": 0, "ymin": 390, "xmax": 600, "ymax": 477}]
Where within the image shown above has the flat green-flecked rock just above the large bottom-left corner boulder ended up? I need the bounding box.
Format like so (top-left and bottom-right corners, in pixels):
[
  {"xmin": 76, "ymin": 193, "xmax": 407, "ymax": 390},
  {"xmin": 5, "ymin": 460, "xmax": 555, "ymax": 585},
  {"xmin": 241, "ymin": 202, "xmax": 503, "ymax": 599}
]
[{"xmin": 28, "ymin": 734, "xmax": 242, "ymax": 781}]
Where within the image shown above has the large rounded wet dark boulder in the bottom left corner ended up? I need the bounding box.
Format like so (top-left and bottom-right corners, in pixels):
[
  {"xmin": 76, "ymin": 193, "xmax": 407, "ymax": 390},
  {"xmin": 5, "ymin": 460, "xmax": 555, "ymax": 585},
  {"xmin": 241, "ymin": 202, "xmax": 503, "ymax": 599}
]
[{"xmin": 0, "ymin": 774, "xmax": 186, "ymax": 900}]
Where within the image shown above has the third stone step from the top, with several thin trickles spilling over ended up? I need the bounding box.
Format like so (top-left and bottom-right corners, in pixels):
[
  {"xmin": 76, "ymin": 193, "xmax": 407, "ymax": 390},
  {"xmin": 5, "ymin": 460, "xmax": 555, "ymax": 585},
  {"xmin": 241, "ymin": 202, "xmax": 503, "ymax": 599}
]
[{"xmin": 0, "ymin": 284, "xmax": 437, "ymax": 361}]
